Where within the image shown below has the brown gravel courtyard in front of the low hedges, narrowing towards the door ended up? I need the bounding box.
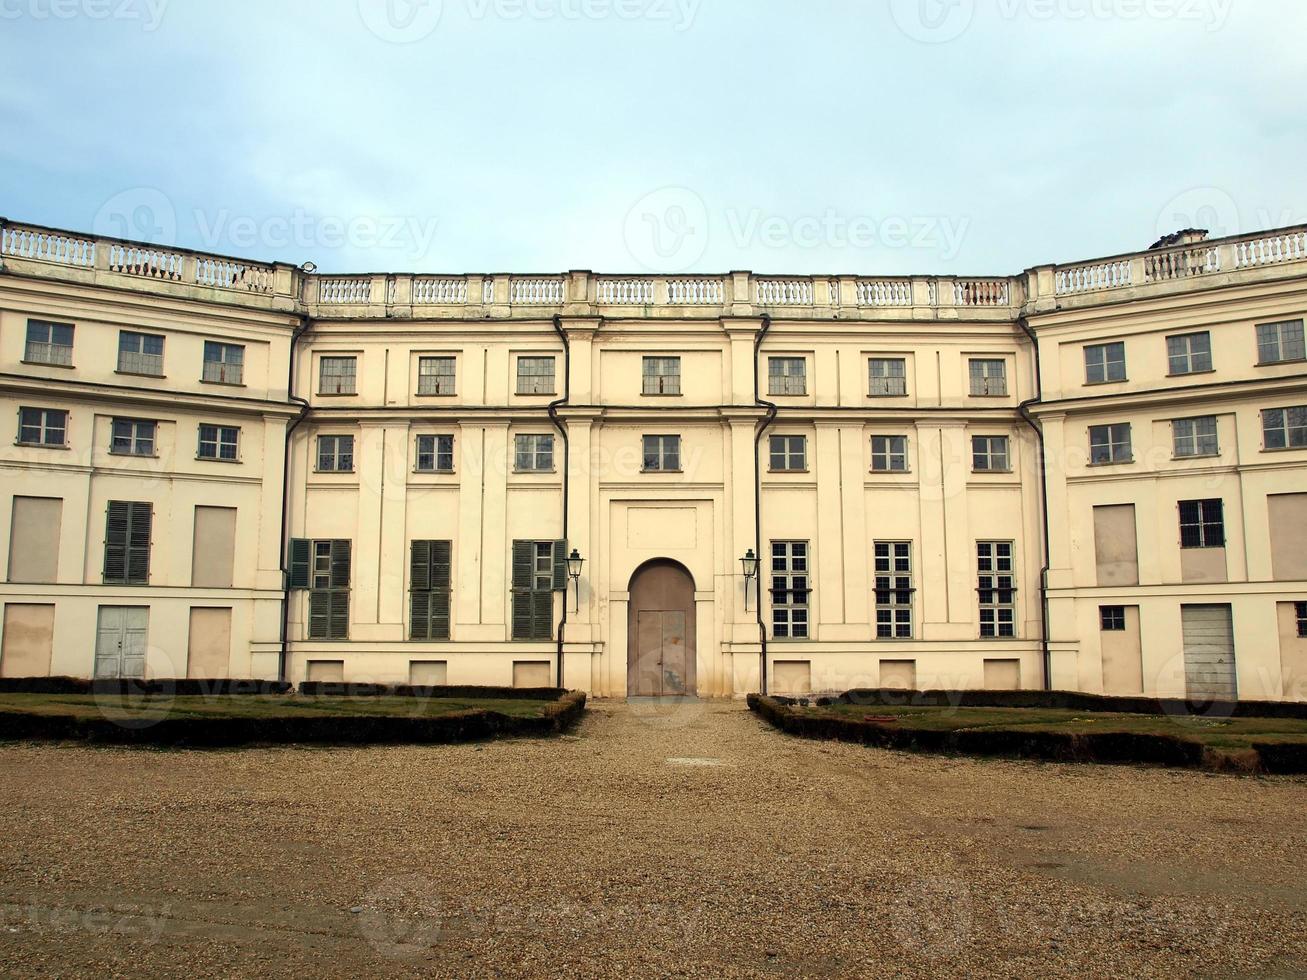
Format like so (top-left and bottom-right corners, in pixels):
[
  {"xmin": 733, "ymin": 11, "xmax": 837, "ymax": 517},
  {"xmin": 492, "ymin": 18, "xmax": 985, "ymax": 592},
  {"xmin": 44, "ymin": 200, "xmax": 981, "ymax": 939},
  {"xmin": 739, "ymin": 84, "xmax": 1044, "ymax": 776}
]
[{"xmin": 0, "ymin": 702, "xmax": 1307, "ymax": 977}]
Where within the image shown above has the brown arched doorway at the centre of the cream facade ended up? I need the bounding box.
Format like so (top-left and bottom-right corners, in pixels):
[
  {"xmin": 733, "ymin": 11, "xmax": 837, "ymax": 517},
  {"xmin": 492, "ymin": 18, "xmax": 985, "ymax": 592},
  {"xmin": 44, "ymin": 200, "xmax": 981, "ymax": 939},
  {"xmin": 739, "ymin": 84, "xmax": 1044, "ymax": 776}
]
[{"xmin": 626, "ymin": 558, "xmax": 697, "ymax": 698}]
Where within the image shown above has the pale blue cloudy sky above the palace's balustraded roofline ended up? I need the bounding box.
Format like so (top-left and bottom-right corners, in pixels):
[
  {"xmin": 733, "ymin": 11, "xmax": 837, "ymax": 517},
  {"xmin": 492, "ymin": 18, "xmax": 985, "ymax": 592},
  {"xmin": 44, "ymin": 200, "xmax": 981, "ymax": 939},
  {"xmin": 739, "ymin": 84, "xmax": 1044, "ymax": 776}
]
[{"xmin": 0, "ymin": 0, "xmax": 1307, "ymax": 274}]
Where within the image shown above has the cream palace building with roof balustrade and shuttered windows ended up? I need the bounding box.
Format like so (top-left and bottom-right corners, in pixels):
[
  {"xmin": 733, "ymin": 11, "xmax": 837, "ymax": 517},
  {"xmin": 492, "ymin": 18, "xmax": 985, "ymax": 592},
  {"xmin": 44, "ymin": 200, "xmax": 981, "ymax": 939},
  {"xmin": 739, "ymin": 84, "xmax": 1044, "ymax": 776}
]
[{"xmin": 0, "ymin": 221, "xmax": 1307, "ymax": 700}]
